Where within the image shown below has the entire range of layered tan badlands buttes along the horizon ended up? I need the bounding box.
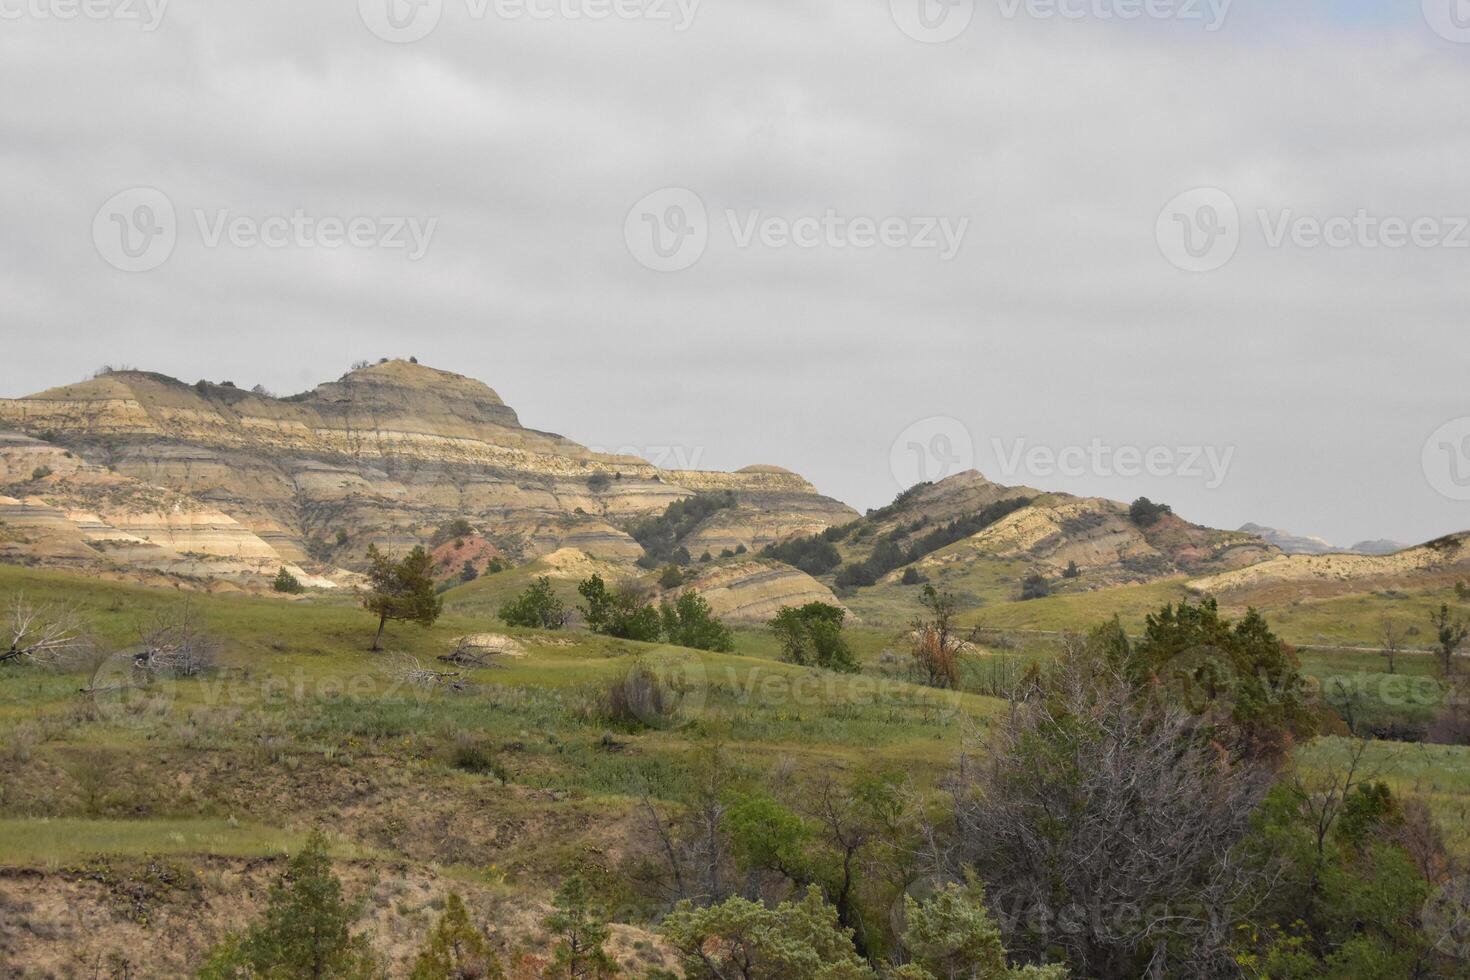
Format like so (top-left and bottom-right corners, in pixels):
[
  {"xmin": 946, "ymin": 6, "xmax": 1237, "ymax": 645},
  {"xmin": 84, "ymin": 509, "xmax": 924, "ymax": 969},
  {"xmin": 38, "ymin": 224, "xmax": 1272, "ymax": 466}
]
[{"xmin": 0, "ymin": 360, "xmax": 1470, "ymax": 621}]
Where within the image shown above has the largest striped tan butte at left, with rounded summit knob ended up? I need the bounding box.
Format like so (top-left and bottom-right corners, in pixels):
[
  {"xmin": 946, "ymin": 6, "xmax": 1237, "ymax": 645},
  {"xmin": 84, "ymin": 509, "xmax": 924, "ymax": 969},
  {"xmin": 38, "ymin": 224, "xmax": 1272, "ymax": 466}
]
[{"xmin": 0, "ymin": 361, "xmax": 854, "ymax": 587}]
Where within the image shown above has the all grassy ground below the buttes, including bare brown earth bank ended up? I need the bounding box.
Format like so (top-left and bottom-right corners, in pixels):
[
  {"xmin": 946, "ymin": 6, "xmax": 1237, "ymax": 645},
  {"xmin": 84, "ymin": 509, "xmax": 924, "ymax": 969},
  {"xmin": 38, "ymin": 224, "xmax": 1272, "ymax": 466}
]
[{"xmin": 0, "ymin": 566, "xmax": 1470, "ymax": 976}]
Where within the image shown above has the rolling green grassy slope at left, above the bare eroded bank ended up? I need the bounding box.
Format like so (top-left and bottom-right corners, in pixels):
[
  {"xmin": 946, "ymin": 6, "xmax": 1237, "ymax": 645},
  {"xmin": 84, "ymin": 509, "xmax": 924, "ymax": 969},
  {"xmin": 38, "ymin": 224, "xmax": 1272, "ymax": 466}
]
[{"xmin": 0, "ymin": 567, "xmax": 997, "ymax": 877}]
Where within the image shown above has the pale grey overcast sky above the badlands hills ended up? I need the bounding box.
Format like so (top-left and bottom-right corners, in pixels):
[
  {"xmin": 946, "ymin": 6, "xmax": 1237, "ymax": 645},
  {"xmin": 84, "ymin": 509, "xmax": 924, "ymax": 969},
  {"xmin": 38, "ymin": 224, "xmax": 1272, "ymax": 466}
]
[{"xmin": 0, "ymin": 0, "xmax": 1470, "ymax": 544}]
